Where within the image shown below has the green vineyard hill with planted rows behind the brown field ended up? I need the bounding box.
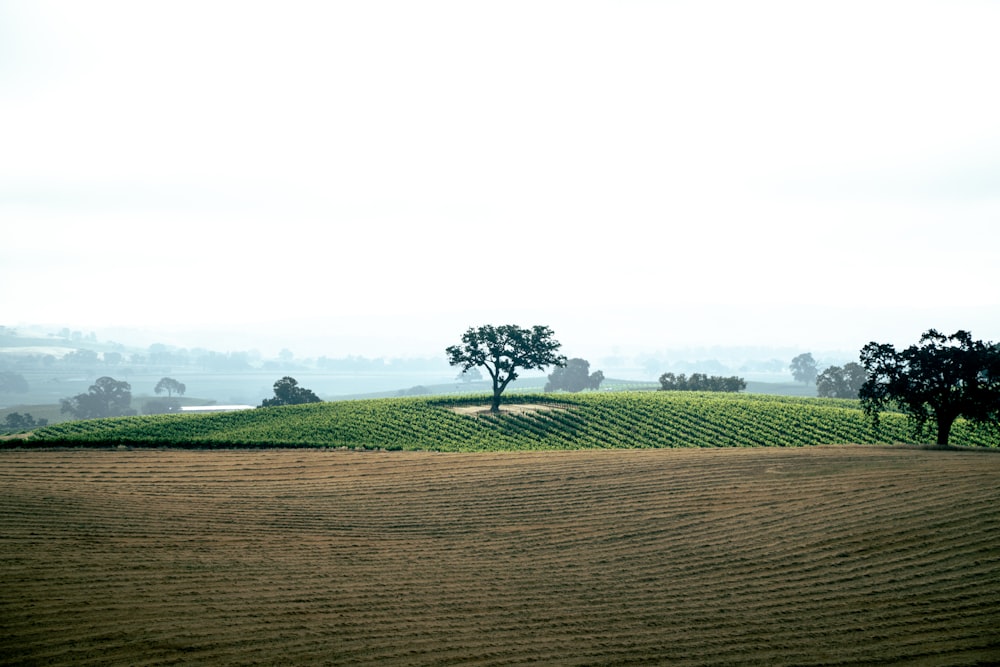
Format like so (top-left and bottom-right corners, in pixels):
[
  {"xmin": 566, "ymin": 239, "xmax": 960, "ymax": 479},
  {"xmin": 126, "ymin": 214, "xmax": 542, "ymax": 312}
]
[{"xmin": 5, "ymin": 392, "xmax": 1000, "ymax": 451}]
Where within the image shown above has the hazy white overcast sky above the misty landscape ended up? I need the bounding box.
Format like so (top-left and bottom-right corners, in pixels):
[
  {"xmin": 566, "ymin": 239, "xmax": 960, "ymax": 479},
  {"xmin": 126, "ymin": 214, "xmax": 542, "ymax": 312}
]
[{"xmin": 0, "ymin": 0, "xmax": 1000, "ymax": 356}]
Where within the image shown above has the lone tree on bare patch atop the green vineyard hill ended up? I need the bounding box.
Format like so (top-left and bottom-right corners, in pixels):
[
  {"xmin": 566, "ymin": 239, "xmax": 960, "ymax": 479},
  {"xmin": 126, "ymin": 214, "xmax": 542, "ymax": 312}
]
[{"xmin": 445, "ymin": 324, "xmax": 566, "ymax": 413}]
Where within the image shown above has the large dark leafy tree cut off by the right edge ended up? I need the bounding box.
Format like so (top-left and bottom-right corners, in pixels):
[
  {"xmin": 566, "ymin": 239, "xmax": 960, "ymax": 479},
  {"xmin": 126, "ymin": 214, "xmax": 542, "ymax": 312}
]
[{"xmin": 859, "ymin": 329, "xmax": 1000, "ymax": 445}]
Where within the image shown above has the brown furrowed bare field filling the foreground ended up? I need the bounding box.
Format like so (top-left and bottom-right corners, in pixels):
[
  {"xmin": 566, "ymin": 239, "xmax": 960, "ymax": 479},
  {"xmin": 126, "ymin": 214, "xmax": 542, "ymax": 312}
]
[{"xmin": 0, "ymin": 447, "xmax": 1000, "ymax": 665}]
